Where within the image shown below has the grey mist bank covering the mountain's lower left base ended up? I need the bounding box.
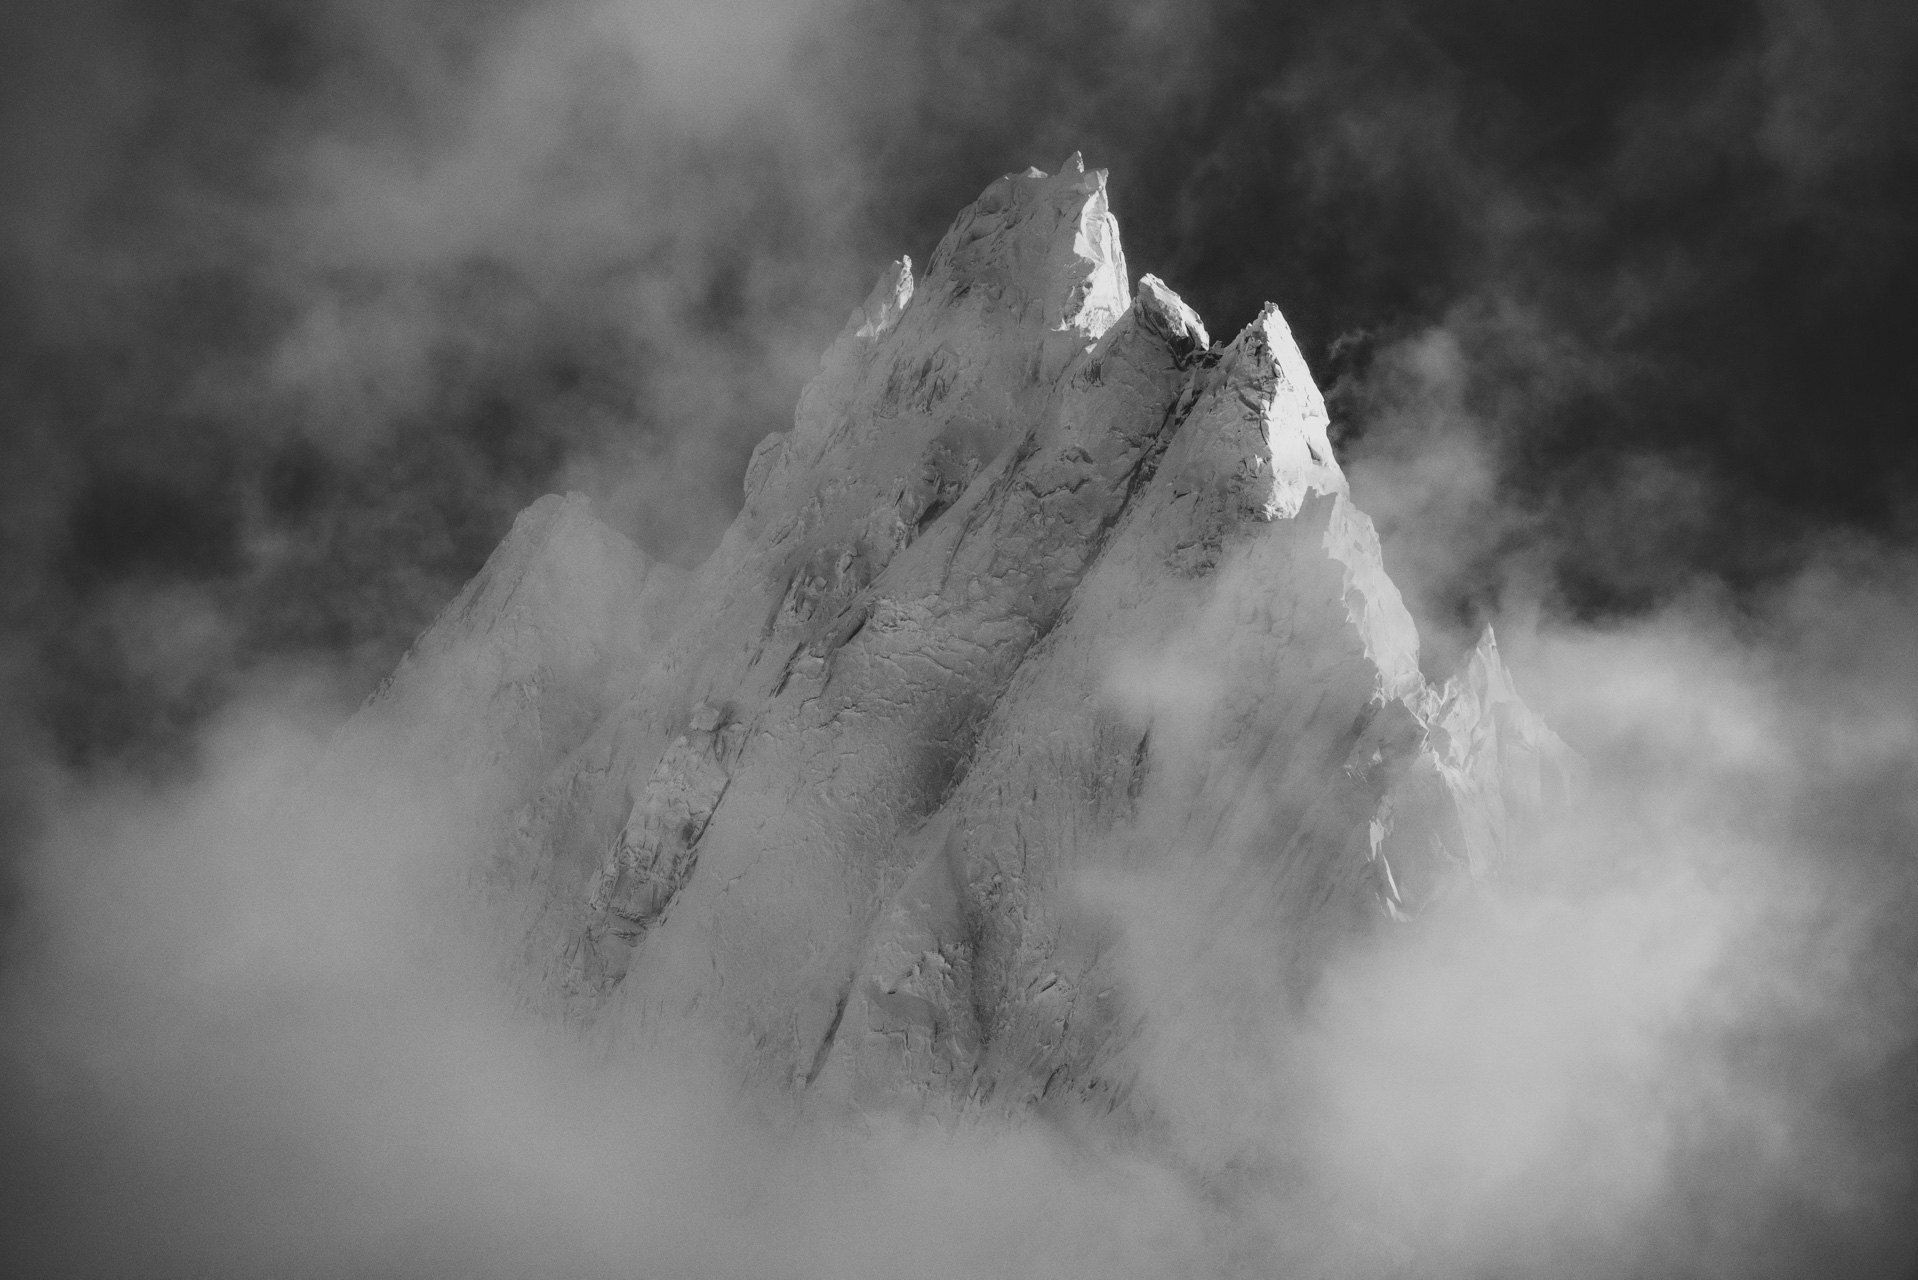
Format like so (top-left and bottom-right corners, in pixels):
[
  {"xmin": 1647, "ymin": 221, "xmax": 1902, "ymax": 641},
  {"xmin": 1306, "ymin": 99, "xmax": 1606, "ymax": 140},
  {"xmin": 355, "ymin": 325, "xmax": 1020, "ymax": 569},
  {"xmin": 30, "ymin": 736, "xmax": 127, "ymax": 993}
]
[{"xmin": 0, "ymin": 687, "xmax": 1242, "ymax": 1276}]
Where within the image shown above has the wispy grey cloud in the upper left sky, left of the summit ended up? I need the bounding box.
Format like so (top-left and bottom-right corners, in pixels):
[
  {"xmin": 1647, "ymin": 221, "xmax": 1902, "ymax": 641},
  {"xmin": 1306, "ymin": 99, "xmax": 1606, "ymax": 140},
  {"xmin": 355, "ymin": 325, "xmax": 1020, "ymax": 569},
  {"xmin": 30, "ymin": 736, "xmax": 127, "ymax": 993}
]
[{"xmin": 0, "ymin": 0, "xmax": 890, "ymax": 771}]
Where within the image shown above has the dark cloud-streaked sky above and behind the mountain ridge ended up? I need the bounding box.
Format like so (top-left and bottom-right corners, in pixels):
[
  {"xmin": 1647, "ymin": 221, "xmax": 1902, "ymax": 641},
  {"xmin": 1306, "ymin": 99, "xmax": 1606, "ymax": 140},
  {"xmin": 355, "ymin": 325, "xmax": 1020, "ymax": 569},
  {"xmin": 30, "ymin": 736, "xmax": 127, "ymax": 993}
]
[{"xmin": 0, "ymin": 0, "xmax": 1918, "ymax": 782}]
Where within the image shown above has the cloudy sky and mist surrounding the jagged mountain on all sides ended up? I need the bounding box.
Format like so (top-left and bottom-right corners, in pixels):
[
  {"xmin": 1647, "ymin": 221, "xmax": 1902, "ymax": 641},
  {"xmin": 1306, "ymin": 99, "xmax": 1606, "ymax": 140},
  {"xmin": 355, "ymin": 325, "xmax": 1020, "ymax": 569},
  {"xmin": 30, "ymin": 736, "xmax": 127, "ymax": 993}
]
[{"xmin": 0, "ymin": 0, "xmax": 1918, "ymax": 1274}]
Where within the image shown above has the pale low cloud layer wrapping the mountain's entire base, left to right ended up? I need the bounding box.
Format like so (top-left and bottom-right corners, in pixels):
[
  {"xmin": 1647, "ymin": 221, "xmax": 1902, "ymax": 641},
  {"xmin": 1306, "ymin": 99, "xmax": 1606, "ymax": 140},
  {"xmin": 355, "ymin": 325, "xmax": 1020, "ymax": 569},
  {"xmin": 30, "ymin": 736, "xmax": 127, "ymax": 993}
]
[{"xmin": 4, "ymin": 518, "xmax": 1918, "ymax": 1276}]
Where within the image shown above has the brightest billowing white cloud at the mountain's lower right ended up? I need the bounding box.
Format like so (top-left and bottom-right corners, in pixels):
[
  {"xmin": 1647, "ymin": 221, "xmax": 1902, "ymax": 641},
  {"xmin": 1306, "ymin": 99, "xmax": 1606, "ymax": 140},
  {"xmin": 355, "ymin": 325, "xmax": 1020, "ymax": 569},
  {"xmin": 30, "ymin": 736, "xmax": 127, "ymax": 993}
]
[{"xmin": 1086, "ymin": 545, "xmax": 1918, "ymax": 1276}]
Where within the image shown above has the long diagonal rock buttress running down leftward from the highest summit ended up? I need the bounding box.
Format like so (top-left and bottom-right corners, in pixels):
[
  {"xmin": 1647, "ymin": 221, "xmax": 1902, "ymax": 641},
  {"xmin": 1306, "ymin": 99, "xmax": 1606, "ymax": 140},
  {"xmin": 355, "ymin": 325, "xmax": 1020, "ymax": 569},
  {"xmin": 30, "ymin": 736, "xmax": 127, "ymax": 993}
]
[{"xmin": 540, "ymin": 157, "xmax": 1130, "ymax": 1002}]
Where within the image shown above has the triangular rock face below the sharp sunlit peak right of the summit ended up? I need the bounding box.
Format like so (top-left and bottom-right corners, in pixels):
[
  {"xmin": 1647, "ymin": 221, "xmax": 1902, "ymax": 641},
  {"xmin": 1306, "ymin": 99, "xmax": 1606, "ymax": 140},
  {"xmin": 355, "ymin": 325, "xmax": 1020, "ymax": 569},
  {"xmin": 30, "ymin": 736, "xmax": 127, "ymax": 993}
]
[{"xmin": 823, "ymin": 309, "xmax": 1425, "ymax": 1107}]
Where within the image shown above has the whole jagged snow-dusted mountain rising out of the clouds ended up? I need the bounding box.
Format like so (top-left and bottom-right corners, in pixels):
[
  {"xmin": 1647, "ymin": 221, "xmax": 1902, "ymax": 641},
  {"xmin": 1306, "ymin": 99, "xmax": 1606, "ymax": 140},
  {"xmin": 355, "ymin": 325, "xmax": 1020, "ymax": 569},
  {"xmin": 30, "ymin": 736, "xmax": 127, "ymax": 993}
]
[{"xmin": 347, "ymin": 155, "xmax": 1569, "ymax": 1128}]
